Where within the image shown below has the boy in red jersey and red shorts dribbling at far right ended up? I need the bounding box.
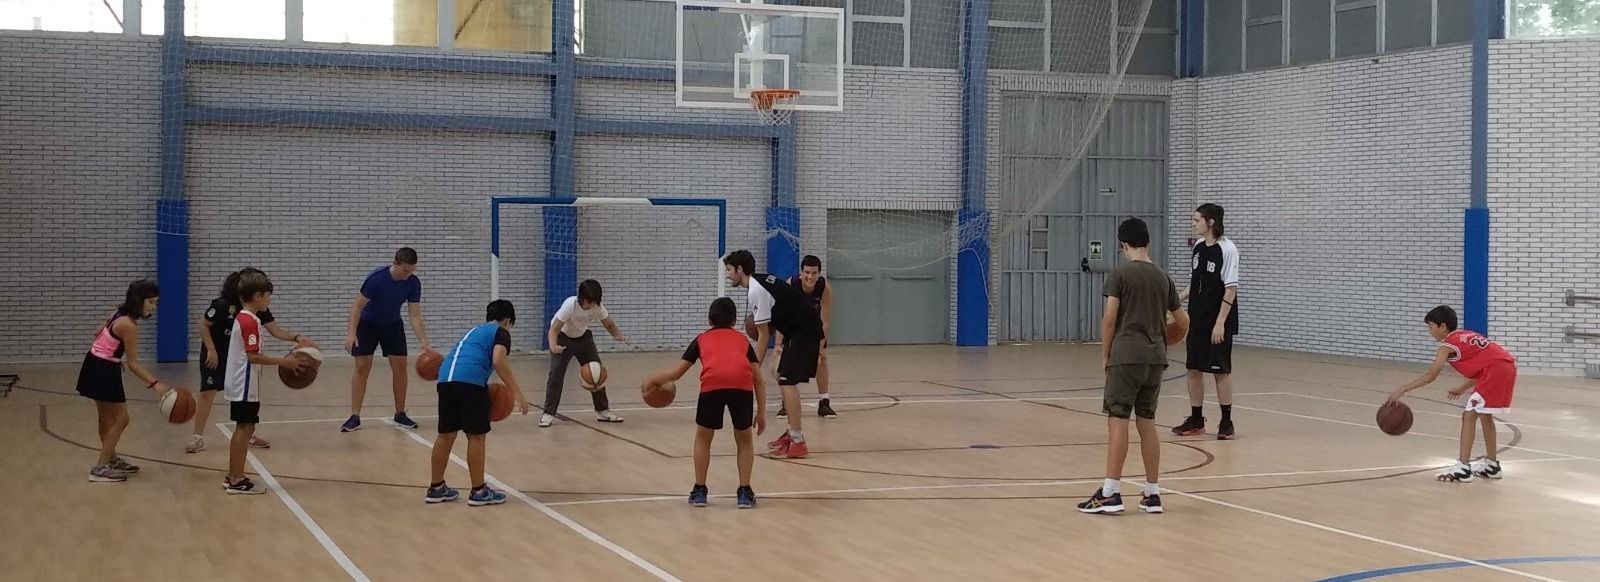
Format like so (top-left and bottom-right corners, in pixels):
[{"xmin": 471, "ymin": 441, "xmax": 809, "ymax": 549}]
[{"xmin": 1389, "ymin": 305, "xmax": 1517, "ymax": 483}]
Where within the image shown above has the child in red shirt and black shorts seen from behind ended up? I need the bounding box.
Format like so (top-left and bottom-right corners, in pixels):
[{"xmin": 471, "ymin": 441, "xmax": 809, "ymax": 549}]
[{"xmin": 640, "ymin": 297, "xmax": 766, "ymax": 508}]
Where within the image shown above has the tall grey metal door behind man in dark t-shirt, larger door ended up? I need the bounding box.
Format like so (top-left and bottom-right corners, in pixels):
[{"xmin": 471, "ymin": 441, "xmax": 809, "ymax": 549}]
[{"xmin": 998, "ymin": 93, "xmax": 1166, "ymax": 342}]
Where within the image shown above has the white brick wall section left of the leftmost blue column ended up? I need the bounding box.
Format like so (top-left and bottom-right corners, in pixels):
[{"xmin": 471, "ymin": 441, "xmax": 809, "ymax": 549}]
[{"xmin": 0, "ymin": 30, "xmax": 162, "ymax": 361}]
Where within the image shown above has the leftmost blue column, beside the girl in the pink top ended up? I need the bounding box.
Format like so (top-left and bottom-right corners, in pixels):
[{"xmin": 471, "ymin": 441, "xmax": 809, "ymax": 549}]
[{"xmin": 155, "ymin": 2, "xmax": 189, "ymax": 361}]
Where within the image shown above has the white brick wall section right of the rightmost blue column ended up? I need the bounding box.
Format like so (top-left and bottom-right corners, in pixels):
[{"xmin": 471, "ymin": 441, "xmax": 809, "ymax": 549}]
[{"xmin": 1488, "ymin": 38, "xmax": 1600, "ymax": 374}]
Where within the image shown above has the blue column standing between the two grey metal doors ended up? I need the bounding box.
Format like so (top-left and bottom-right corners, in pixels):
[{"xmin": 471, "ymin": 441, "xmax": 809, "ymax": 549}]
[{"xmin": 955, "ymin": 0, "xmax": 989, "ymax": 345}]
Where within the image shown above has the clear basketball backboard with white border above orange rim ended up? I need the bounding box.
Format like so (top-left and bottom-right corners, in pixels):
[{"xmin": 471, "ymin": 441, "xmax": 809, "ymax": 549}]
[{"xmin": 677, "ymin": 0, "xmax": 845, "ymax": 112}]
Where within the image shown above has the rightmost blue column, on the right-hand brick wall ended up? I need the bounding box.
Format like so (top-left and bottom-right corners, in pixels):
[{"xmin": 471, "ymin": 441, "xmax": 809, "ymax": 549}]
[{"xmin": 1461, "ymin": 0, "xmax": 1506, "ymax": 334}]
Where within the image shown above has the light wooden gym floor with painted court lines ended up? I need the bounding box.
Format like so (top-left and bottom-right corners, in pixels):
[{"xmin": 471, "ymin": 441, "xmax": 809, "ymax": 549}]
[{"xmin": 0, "ymin": 340, "xmax": 1600, "ymax": 580}]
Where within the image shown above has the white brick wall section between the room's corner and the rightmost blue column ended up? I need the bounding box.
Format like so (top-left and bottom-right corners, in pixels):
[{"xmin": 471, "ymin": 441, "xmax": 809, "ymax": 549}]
[{"xmin": 1168, "ymin": 46, "xmax": 1470, "ymax": 360}]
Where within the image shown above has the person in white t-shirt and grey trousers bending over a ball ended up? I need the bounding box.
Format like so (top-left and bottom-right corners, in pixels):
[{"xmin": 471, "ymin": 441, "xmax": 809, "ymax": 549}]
[{"xmin": 539, "ymin": 278, "xmax": 627, "ymax": 427}]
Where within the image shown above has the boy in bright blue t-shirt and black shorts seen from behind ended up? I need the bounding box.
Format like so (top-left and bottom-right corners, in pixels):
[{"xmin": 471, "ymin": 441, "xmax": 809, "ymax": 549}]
[{"xmin": 424, "ymin": 299, "xmax": 528, "ymax": 507}]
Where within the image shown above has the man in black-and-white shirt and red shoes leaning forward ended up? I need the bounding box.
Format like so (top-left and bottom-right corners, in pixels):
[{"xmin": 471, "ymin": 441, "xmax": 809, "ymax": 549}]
[{"xmin": 722, "ymin": 251, "xmax": 826, "ymax": 459}]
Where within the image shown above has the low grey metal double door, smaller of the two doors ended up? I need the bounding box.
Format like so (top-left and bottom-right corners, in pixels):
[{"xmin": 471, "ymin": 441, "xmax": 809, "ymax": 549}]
[{"xmin": 824, "ymin": 209, "xmax": 950, "ymax": 344}]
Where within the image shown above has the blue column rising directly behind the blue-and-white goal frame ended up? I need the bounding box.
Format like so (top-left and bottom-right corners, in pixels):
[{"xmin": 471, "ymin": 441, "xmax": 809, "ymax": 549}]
[{"xmin": 539, "ymin": 0, "xmax": 578, "ymax": 349}]
